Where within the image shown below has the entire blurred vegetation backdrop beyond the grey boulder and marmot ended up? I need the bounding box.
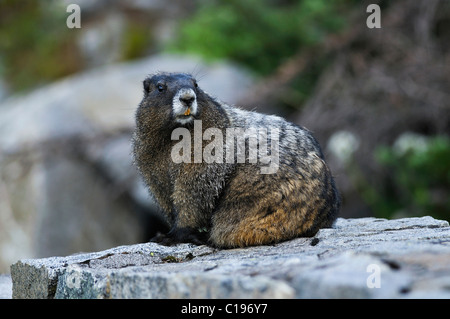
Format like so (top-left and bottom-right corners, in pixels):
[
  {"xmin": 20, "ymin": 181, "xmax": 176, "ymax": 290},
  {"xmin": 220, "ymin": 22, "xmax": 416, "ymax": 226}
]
[{"xmin": 0, "ymin": 0, "xmax": 450, "ymax": 272}]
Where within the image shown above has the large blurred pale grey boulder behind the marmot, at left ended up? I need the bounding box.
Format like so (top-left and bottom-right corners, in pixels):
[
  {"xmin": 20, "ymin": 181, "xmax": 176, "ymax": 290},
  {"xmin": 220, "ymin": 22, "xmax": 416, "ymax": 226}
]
[{"xmin": 0, "ymin": 54, "xmax": 252, "ymax": 273}]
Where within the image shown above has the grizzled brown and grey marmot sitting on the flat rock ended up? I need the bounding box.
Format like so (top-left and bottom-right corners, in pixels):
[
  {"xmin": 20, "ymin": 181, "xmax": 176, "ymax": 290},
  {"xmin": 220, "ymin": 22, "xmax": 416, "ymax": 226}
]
[{"xmin": 133, "ymin": 72, "xmax": 340, "ymax": 248}]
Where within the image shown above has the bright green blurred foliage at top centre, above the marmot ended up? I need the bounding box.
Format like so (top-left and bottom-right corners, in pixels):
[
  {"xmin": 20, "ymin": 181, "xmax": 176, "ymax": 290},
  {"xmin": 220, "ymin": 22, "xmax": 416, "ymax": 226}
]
[{"xmin": 172, "ymin": 0, "xmax": 354, "ymax": 75}]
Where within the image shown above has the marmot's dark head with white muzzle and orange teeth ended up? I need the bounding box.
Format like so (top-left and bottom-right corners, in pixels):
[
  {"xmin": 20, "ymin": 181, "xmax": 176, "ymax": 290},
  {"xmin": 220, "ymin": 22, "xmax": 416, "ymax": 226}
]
[{"xmin": 140, "ymin": 73, "xmax": 206, "ymax": 125}]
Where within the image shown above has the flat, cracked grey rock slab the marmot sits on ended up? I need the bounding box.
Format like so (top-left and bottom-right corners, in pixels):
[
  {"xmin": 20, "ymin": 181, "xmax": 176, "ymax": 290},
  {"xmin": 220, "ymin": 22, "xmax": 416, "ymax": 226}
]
[{"xmin": 11, "ymin": 217, "xmax": 450, "ymax": 298}]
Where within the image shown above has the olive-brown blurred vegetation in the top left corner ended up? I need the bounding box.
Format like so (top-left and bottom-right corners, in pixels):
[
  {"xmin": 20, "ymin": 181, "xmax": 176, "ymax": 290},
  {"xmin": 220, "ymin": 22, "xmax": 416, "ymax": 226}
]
[{"xmin": 0, "ymin": 0, "xmax": 82, "ymax": 91}]
